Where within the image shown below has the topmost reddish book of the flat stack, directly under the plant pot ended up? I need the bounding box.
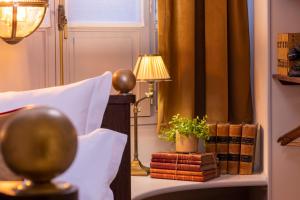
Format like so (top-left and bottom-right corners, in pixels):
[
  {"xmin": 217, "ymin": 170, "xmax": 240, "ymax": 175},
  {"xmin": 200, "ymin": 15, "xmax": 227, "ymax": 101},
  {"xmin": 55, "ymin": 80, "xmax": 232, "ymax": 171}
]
[{"xmin": 152, "ymin": 152, "xmax": 215, "ymax": 162}]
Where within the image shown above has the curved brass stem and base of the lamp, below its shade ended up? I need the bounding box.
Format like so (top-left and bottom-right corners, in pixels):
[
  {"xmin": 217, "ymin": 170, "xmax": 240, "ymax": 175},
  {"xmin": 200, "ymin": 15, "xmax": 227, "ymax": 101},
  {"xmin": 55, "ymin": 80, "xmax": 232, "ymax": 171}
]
[{"xmin": 131, "ymin": 82, "xmax": 154, "ymax": 176}]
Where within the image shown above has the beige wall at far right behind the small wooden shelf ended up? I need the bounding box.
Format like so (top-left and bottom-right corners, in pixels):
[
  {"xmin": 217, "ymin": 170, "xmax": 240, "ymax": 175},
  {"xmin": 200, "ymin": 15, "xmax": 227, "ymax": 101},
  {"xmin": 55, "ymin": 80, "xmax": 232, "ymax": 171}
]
[{"xmin": 270, "ymin": 0, "xmax": 300, "ymax": 200}]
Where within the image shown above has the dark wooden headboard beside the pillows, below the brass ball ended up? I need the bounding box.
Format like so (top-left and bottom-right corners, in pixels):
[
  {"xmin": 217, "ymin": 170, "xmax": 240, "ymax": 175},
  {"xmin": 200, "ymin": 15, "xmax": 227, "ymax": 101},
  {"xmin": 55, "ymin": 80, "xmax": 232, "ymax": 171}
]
[{"xmin": 102, "ymin": 94, "xmax": 135, "ymax": 200}]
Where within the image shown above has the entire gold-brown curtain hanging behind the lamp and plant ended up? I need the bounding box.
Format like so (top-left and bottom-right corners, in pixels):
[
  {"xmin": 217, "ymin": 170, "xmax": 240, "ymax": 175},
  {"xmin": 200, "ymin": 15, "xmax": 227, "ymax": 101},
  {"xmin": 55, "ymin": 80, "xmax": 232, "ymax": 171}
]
[{"xmin": 158, "ymin": 0, "xmax": 252, "ymax": 128}]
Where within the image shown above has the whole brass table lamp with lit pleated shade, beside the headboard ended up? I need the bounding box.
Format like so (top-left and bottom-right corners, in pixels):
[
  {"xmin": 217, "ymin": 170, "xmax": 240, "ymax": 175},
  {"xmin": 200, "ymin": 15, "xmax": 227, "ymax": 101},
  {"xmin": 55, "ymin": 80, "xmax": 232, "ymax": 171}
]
[{"xmin": 131, "ymin": 55, "xmax": 171, "ymax": 176}]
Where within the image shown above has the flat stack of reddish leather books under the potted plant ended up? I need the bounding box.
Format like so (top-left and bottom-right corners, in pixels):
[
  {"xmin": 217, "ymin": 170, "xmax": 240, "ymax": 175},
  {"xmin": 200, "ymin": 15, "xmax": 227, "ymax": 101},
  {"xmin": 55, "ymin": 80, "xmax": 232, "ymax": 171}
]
[{"xmin": 150, "ymin": 153, "xmax": 218, "ymax": 182}]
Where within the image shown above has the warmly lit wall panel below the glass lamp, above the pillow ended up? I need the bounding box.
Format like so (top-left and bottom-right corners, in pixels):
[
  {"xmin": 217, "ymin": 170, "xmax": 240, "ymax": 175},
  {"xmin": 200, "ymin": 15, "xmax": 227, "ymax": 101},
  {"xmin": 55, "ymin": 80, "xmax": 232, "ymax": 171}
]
[{"xmin": 0, "ymin": 29, "xmax": 55, "ymax": 91}]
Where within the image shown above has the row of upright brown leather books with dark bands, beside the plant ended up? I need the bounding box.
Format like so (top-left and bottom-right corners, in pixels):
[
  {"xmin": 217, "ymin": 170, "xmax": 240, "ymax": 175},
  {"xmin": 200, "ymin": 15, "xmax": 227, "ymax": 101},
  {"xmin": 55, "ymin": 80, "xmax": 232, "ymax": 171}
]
[{"xmin": 206, "ymin": 123, "xmax": 258, "ymax": 175}]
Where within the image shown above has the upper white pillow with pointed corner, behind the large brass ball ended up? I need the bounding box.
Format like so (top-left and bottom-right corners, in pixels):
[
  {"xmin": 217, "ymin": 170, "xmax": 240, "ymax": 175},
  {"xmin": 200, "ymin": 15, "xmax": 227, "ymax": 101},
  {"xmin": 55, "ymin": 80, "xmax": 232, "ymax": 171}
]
[{"xmin": 0, "ymin": 72, "xmax": 112, "ymax": 135}]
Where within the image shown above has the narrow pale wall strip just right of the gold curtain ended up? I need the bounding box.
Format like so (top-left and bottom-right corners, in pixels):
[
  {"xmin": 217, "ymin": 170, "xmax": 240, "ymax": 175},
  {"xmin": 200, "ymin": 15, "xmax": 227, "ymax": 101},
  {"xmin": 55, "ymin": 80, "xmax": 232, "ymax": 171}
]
[{"xmin": 254, "ymin": 0, "xmax": 270, "ymax": 180}]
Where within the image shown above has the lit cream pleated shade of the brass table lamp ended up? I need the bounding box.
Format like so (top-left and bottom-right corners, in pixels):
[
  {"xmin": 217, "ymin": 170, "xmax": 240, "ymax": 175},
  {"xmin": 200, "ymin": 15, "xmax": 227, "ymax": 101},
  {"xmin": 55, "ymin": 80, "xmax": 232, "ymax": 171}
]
[{"xmin": 133, "ymin": 55, "xmax": 171, "ymax": 82}]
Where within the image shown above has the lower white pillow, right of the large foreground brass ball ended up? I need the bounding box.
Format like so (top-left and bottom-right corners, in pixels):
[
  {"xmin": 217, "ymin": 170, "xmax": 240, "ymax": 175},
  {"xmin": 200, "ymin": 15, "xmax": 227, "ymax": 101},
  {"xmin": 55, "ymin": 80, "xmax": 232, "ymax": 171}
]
[{"xmin": 56, "ymin": 129, "xmax": 127, "ymax": 200}]
